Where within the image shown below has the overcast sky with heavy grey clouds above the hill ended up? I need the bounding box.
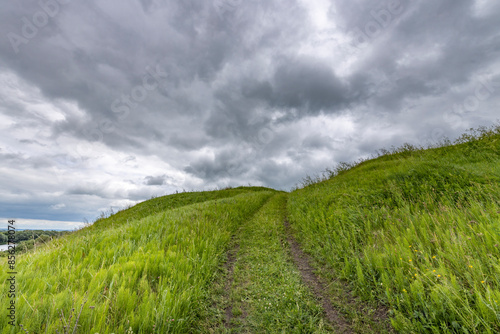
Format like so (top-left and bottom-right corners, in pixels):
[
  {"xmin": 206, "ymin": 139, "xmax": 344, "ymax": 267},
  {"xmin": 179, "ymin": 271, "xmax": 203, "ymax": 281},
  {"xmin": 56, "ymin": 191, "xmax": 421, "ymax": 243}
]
[{"xmin": 0, "ymin": 0, "xmax": 500, "ymax": 228}]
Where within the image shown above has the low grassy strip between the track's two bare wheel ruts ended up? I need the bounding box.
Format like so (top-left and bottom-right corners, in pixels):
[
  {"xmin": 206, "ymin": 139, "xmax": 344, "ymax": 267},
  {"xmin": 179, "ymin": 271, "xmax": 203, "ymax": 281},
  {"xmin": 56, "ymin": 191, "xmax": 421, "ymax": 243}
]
[{"xmin": 223, "ymin": 193, "xmax": 331, "ymax": 334}]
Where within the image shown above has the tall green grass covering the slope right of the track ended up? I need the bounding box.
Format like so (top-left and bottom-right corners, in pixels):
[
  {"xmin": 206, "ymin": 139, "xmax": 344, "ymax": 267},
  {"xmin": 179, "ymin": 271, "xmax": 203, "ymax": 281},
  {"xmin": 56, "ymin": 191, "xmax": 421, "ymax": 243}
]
[{"xmin": 288, "ymin": 127, "xmax": 500, "ymax": 333}]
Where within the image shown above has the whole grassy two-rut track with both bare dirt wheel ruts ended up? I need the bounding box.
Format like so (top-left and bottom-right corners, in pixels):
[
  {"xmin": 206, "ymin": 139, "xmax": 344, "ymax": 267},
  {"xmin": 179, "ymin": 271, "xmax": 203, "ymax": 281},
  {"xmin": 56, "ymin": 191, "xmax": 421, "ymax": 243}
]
[{"xmin": 205, "ymin": 194, "xmax": 392, "ymax": 334}]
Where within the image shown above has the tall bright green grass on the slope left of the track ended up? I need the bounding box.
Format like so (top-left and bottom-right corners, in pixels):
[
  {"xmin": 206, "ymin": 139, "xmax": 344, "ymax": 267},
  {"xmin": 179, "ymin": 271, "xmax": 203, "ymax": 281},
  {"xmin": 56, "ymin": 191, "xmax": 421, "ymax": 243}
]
[{"xmin": 0, "ymin": 191, "xmax": 272, "ymax": 334}]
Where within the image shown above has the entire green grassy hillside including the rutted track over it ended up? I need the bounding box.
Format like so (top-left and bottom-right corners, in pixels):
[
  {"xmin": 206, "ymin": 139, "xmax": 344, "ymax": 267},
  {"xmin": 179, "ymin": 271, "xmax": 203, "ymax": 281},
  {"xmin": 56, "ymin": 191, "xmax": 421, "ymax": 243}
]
[{"xmin": 0, "ymin": 127, "xmax": 500, "ymax": 334}]
